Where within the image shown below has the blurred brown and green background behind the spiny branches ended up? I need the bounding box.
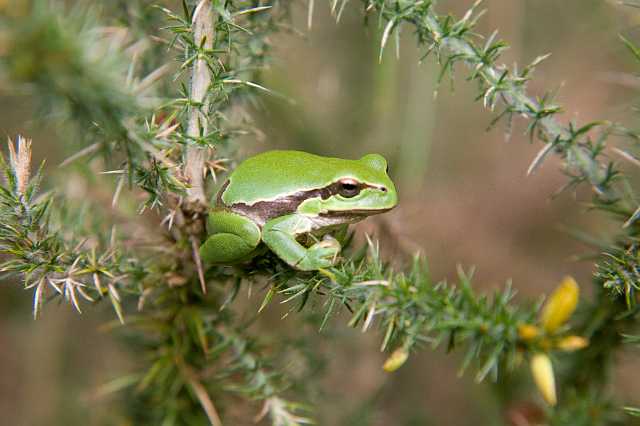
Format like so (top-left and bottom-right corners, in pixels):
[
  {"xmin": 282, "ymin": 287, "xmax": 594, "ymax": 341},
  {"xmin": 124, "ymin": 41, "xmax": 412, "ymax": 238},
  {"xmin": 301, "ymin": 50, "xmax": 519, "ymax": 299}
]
[{"xmin": 0, "ymin": 0, "xmax": 640, "ymax": 426}]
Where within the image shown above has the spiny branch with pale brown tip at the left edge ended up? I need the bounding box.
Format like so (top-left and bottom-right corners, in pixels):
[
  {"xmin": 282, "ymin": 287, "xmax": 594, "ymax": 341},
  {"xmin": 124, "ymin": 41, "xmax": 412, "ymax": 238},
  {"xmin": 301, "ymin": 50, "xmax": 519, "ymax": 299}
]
[{"xmin": 0, "ymin": 137, "xmax": 149, "ymax": 323}]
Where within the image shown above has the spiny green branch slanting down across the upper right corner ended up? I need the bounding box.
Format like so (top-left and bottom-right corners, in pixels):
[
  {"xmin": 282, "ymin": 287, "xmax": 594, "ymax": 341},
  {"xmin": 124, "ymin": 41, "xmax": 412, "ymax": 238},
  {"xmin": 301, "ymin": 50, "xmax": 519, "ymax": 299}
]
[{"xmin": 364, "ymin": 0, "xmax": 633, "ymax": 211}]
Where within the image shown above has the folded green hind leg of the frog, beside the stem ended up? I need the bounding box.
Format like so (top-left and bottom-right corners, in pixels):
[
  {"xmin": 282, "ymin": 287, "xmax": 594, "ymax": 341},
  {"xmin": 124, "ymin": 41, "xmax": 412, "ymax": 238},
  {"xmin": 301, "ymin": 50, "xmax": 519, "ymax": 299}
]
[{"xmin": 200, "ymin": 210, "xmax": 261, "ymax": 264}]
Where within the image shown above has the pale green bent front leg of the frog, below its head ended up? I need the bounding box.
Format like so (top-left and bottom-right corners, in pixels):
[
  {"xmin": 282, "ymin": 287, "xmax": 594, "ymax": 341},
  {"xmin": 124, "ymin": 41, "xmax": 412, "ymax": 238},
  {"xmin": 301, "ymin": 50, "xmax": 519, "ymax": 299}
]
[{"xmin": 262, "ymin": 214, "xmax": 341, "ymax": 271}]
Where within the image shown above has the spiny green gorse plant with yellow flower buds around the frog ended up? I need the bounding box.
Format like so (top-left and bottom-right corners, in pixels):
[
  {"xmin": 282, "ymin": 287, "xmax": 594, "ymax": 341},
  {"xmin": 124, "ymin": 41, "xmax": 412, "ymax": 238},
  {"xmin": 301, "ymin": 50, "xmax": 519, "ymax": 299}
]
[{"xmin": 0, "ymin": 0, "xmax": 640, "ymax": 426}]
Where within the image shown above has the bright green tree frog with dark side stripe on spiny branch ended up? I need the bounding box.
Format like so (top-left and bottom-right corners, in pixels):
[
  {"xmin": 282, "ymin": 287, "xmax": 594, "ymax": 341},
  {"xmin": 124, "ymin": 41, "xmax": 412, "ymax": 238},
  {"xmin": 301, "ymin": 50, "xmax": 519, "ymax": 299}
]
[{"xmin": 200, "ymin": 151, "xmax": 398, "ymax": 271}]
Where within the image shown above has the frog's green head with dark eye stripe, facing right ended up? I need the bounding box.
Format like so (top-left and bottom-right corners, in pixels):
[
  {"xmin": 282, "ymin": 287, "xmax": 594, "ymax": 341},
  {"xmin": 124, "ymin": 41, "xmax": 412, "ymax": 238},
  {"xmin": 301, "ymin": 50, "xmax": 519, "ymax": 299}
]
[{"xmin": 298, "ymin": 154, "xmax": 398, "ymax": 219}]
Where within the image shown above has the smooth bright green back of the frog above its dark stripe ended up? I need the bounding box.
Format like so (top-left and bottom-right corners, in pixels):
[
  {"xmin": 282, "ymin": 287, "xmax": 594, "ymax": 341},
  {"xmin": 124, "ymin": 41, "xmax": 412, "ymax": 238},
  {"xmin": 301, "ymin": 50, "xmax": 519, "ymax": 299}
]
[{"xmin": 219, "ymin": 151, "xmax": 354, "ymax": 206}]
